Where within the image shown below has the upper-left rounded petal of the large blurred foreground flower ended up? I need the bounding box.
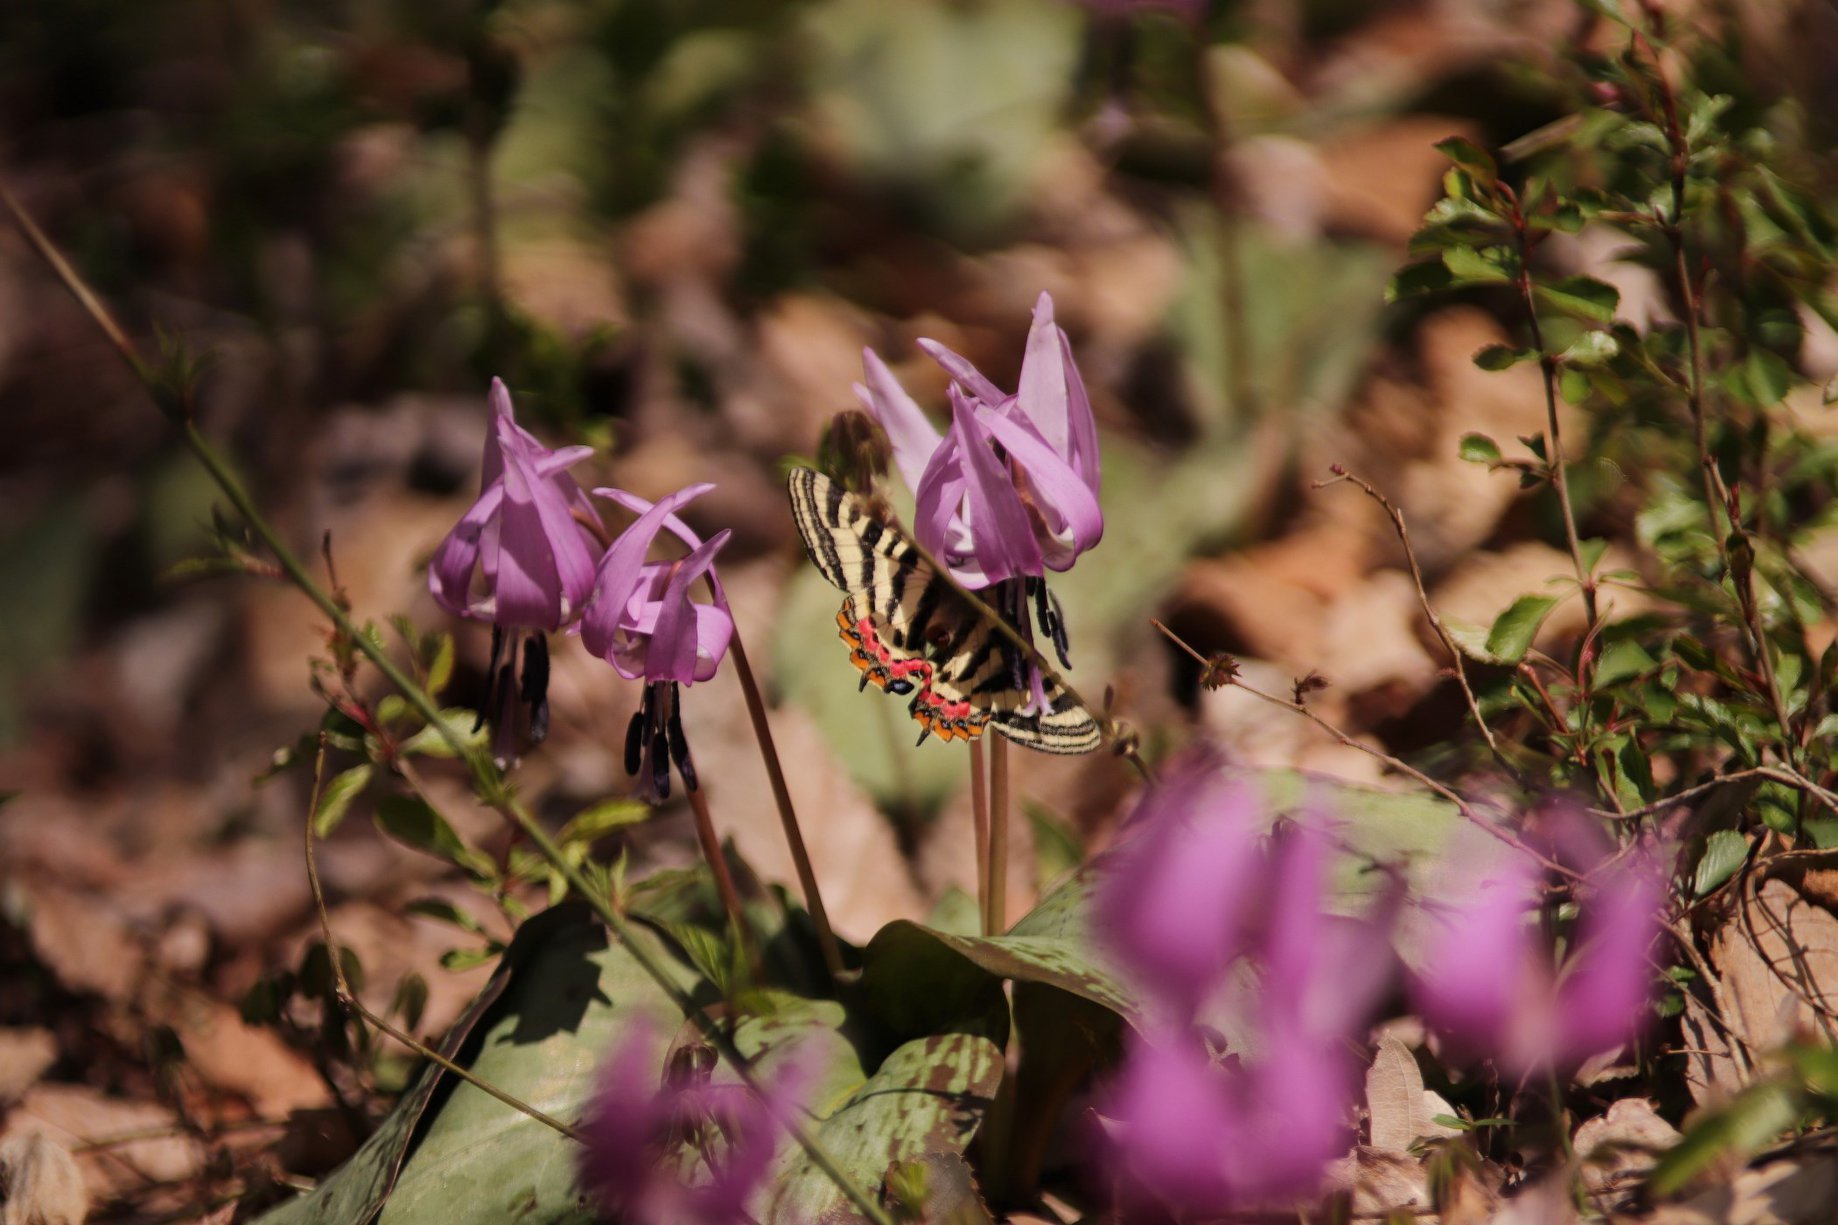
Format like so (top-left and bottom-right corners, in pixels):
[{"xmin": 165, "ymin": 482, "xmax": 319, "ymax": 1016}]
[{"xmin": 1097, "ymin": 752, "xmax": 1263, "ymax": 1021}]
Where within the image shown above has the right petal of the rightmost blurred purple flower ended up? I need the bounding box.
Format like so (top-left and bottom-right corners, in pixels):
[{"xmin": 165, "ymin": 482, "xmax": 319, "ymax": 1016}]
[{"xmin": 1551, "ymin": 866, "xmax": 1665, "ymax": 1063}]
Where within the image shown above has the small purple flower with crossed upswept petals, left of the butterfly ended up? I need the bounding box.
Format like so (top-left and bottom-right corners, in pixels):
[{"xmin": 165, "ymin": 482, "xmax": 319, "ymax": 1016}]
[{"xmin": 581, "ymin": 484, "xmax": 733, "ymax": 798}]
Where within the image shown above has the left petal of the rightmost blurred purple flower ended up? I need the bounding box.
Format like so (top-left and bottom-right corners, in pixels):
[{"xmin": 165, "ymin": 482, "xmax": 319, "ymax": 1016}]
[{"xmin": 1417, "ymin": 857, "xmax": 1540, "ymax": 1050}]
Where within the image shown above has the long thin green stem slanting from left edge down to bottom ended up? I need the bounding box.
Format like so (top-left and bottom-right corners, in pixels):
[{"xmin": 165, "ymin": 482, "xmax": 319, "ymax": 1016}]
[{"xmin": 0, "ymin": 182, "xmax": 893, "ymax": 1225}]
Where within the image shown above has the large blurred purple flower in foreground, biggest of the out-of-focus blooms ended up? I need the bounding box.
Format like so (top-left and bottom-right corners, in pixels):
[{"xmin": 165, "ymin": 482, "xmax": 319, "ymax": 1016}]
[{"xmin": 1097, "ymin": 752, "xmax": 1393, "ymax": 1216}]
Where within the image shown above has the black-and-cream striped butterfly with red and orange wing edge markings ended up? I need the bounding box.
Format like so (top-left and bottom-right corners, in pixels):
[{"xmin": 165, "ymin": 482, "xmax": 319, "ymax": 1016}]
[{"xmin": 789, "ymin": 467, "xmax": 1103, "ymax": 752}]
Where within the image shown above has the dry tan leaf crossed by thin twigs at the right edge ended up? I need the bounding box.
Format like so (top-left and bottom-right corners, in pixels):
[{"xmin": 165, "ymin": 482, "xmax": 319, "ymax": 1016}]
[{"xmin": 1711, "ymin": 881, "xmax": 1838, "ymax": 1052}]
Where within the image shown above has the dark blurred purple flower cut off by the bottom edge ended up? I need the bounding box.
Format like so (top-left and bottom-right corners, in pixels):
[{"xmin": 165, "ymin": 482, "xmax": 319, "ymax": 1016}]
[{"xmin": 579, "ymin": 1028, "xmax": 809, "ymax": 1225}]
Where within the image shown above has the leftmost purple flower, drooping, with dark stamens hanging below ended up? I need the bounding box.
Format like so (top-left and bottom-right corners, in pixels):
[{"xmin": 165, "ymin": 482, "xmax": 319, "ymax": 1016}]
[{"xmin": 428, "ymin": 379, "xmax": 599, "ymax": 760}]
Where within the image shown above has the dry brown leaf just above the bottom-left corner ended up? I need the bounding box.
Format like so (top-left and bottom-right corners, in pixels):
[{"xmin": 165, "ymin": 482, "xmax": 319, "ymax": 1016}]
[{"xmin": 4, "ymin": 1085, "xmax": 204, "ymax": 1199}]
